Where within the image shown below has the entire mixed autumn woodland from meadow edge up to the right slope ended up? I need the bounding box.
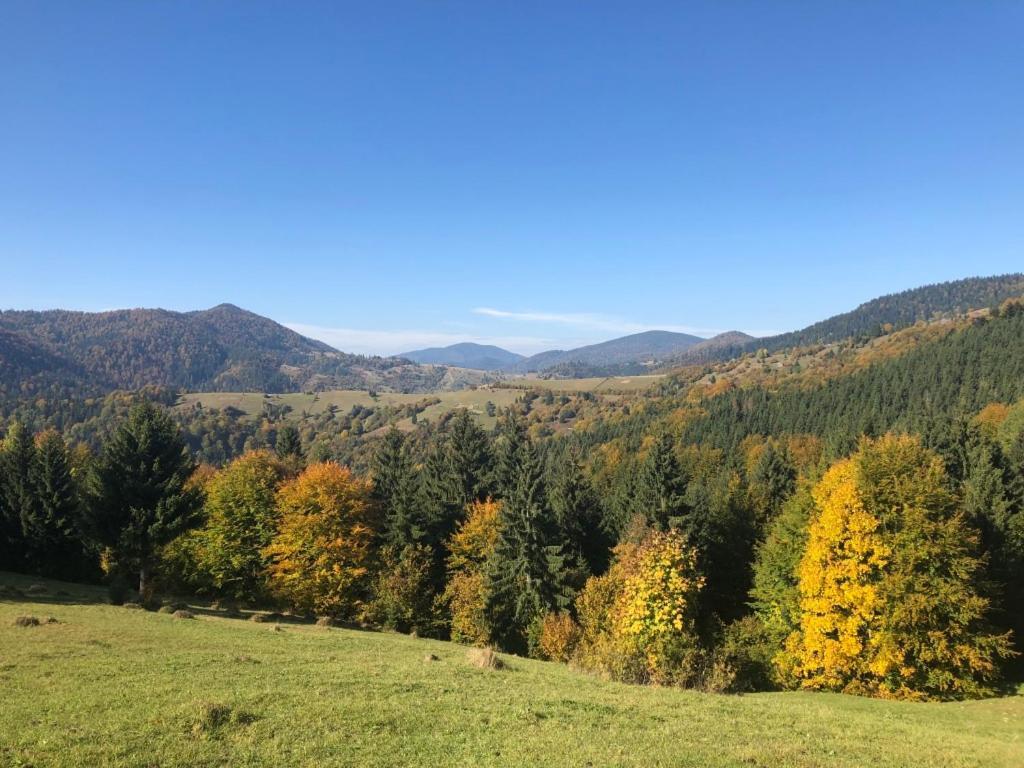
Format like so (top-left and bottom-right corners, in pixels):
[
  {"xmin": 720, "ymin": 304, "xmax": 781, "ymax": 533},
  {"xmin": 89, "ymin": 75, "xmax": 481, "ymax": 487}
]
[{"xmin": 0, "ymin": 278, "xmax": 1024, "ymax": 699}]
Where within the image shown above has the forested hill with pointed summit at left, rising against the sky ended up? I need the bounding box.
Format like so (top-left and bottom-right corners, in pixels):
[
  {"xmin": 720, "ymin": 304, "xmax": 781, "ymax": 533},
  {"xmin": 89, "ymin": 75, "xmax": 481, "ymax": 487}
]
[{"xmin": 0, "ymin": 304, "xmax": 444, "ymax": 395}]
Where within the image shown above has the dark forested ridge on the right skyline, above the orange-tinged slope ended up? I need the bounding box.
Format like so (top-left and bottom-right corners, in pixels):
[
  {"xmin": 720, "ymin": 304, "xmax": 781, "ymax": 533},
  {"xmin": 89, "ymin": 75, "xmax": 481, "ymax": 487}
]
[{"xmin": 673, "ymin": 272, "xmax": 1024, "ymax": 365}]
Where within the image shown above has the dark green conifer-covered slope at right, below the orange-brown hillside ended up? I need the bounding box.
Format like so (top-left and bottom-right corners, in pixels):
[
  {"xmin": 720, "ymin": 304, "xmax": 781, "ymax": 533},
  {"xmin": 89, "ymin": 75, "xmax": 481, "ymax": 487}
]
[{"xmin": 671, "ymin": 303, "xmax": 1024, "ymax": 456}]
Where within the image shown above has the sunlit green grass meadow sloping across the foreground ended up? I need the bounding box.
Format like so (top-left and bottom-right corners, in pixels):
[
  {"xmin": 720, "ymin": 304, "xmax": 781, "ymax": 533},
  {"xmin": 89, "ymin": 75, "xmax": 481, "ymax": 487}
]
[{"xmin": 0, "ymin": 573, "xmax": 1024, "ymax": 768}]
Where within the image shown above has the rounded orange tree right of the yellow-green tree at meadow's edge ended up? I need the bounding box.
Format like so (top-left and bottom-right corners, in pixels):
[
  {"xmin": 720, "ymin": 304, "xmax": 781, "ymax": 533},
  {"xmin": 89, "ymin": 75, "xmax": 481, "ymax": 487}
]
[{"xmin": 264, "ymin": 462, "xmax": 378, "ymax": 617}]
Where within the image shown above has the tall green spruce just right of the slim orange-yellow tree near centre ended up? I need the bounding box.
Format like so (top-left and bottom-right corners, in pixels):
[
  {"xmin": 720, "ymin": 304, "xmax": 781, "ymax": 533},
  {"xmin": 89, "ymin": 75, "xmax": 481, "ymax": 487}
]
[{"xmin": 485, "ymin": 442, "xmax": 568, "ymax": 653}]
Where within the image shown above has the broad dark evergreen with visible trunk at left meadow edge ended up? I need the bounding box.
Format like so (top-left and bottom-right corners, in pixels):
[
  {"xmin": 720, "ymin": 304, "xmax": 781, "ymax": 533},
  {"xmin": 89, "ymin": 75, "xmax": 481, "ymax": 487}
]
[{"xmin": 88, "ymin": 401, "xmax": 202, "ymax": 596}]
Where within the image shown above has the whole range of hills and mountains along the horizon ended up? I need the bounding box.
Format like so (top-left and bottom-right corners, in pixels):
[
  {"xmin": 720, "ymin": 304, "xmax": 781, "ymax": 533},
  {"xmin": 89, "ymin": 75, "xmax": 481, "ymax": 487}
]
[{"xmin": 0, "ymin": 273, "xmax": 1024, "ymax": 399}]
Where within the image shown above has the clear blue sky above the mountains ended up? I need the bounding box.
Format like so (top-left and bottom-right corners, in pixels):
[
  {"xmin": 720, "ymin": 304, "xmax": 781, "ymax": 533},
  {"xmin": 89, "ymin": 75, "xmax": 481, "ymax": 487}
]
[{"xmin": 0, "ymin": 0, "xmax": 1024, "ymax": 352}]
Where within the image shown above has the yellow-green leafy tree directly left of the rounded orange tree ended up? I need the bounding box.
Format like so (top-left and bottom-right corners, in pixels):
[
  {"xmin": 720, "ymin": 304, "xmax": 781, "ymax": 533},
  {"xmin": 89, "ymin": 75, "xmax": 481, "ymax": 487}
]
[{"xmin": 195, "ymin": 451, "xmax": 288, "ymax": 600}]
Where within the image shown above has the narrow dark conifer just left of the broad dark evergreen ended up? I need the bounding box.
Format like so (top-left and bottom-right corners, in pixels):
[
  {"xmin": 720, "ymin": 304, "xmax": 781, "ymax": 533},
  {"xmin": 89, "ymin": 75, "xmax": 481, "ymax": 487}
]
[{"xmin": 23, "ymin": 429, "xmax": 88, "ymax": 579}]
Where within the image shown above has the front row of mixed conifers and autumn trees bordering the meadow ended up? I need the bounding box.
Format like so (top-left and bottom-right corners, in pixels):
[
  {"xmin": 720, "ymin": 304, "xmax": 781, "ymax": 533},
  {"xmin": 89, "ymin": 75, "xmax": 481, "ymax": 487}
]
[{"xmin": 0, "ymin": 393, "xmax": 1024, "ymax": 698}]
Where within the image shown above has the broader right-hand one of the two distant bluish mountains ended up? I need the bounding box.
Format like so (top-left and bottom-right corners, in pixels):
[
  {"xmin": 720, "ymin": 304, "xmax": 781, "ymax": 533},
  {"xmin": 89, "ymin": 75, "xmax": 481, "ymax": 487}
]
[{"xmin": 513, "ymin": 331, "xmax": 707, "ymax": 375}]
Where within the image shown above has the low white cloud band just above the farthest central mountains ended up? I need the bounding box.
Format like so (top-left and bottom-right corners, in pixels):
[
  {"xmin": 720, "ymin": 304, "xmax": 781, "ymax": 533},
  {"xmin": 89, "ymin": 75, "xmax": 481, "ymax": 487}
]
[{"xmin": 285, "ymin": 323, "xmax": 555, "ymax": 355}]
